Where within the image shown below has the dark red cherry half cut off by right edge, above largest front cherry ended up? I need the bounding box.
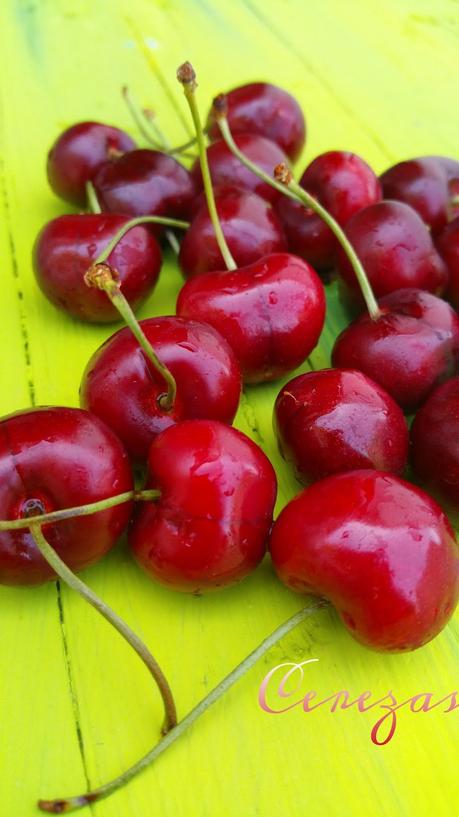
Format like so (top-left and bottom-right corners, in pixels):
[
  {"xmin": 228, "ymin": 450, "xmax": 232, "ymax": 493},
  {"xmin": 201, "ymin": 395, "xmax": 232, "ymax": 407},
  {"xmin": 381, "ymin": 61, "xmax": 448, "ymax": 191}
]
[{"xmin": 411, "ymin": 377, "xmax": 459, "ymax": 507}]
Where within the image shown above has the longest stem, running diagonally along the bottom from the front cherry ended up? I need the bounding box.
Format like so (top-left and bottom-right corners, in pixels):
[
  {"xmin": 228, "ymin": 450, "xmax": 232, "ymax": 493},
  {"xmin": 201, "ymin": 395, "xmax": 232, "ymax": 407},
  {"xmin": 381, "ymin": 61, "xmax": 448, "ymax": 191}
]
[{"xmin": 38, "ymin": 599, "xmax": 328, "ymax": 814}]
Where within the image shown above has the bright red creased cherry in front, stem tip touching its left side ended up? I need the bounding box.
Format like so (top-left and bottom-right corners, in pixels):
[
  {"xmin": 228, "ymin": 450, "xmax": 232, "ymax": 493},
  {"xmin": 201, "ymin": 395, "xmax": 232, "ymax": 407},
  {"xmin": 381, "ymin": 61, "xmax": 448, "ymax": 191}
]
[{"xmin": 129, "ymin": 420, "xmax": 277, "ymax": 593}]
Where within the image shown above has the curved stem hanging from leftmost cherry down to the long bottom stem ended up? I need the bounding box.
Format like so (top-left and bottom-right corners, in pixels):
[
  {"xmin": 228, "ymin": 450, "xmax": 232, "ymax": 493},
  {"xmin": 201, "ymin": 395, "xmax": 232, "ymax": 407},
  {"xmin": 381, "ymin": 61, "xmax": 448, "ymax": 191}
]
[{"xmin": 29, "ymin": 518, "xmax": 177, "ymax": 734}]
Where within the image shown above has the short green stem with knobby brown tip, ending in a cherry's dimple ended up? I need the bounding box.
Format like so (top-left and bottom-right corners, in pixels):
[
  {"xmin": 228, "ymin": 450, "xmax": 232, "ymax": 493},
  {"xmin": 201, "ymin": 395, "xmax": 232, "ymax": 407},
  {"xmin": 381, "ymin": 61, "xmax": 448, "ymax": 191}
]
[{"xmin": 84, "ymin": 262, "xmax": 177, "ymax": 411}]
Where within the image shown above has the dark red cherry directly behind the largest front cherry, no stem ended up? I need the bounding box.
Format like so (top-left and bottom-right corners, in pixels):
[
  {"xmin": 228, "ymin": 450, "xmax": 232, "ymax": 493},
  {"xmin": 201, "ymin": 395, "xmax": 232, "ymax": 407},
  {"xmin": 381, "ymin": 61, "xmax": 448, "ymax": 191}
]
[{"xmin": 274, "ymin": 369, "xmax": 408, "ymax": 482}]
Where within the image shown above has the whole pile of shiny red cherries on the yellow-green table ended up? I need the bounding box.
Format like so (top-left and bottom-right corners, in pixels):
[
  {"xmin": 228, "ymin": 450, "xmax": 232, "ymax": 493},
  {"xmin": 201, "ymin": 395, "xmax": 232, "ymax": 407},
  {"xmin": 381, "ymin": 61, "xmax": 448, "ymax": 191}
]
[{"xmin": 4, "ymin": 64, "xmax": 459, "ymax": 808}]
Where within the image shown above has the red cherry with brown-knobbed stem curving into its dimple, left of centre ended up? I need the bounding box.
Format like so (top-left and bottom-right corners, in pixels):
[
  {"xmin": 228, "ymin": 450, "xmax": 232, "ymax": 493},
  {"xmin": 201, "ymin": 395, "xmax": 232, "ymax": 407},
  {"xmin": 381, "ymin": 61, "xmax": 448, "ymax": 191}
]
[{"xmin": 80, "ymin": 317, "xmax": 241, "ymax": 460}]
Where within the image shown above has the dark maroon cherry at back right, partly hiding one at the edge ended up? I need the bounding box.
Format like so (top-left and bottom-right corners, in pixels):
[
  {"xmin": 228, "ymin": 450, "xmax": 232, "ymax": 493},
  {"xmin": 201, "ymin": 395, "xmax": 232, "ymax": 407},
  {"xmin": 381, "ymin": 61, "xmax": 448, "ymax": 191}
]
[{"xmin": 381, "ymin": 157, "xmax": 450, "ymax": 233}]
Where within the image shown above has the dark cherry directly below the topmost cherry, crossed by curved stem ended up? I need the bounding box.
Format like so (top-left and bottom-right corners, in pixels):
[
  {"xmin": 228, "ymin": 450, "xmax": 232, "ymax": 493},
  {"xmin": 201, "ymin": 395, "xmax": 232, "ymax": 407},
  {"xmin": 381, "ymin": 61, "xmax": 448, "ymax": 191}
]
[{"xmin": 191, "ymin": 133, "xmax": 288, "ymax": 204}]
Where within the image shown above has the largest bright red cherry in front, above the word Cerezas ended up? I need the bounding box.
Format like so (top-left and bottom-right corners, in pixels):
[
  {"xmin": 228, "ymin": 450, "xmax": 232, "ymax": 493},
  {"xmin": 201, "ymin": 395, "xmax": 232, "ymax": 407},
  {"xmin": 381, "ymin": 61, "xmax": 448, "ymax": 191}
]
[{"xmin": 270, "ymin": 471, "xmax": 459, "ymax": 652}]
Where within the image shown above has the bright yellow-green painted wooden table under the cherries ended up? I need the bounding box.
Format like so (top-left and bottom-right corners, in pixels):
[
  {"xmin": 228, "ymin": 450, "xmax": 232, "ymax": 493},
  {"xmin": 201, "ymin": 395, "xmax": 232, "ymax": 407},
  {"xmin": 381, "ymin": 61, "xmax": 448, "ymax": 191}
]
[{"xmin": 0, "ymin": 0, "xmax": 459, "ymax": 817}]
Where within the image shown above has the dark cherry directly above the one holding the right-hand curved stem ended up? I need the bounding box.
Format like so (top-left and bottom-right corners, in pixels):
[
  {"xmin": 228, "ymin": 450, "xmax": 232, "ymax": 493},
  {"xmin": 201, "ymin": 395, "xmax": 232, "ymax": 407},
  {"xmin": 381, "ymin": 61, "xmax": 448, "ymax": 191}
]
[{"xmin": 337, "ymin": 201, "xmax": 448, "ymax": 298}]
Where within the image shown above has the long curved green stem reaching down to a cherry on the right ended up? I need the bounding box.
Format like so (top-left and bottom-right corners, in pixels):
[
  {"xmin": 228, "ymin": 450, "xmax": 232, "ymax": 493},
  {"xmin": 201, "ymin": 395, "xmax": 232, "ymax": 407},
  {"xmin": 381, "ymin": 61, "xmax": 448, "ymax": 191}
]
[{"xmin": 213, "ymin": 95, "xmax": 381, "ymax": 320}]
